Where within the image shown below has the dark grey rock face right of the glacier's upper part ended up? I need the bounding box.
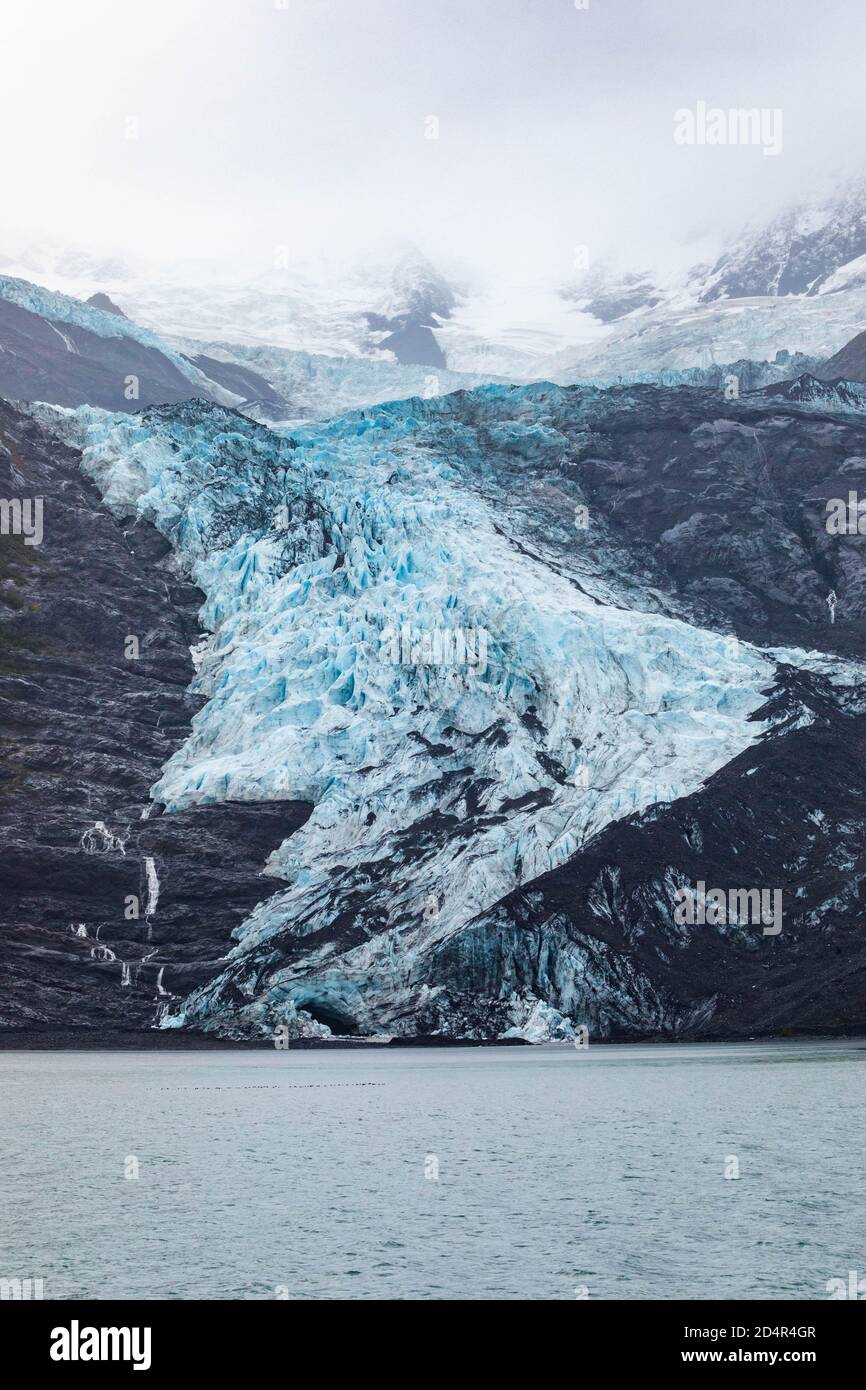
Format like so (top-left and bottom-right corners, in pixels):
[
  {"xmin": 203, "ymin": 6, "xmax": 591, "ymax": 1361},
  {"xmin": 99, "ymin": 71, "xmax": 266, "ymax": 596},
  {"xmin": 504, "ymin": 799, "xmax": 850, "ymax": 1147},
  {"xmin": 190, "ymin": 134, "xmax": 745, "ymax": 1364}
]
[{"xmin": 450, "ymin": 377, "xmax": 866, "ymax": 657}]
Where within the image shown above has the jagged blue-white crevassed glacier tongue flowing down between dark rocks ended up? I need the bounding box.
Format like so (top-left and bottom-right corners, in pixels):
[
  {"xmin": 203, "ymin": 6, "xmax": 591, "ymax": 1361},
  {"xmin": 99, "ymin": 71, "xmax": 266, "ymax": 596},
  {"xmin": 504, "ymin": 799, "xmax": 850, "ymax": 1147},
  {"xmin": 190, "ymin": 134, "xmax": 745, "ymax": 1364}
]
[{"xmin": 67, "ymin": 388, "xmax": 774, "ymax": 1034}]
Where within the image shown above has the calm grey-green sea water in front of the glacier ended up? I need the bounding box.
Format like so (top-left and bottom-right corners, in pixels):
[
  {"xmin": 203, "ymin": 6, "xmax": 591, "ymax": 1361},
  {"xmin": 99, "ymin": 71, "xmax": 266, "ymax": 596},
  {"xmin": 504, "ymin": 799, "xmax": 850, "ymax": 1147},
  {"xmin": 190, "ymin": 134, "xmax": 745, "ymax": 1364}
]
[{"xmin": 0, "ymin": 1041, "xmax": 866, "ymax": 1300}]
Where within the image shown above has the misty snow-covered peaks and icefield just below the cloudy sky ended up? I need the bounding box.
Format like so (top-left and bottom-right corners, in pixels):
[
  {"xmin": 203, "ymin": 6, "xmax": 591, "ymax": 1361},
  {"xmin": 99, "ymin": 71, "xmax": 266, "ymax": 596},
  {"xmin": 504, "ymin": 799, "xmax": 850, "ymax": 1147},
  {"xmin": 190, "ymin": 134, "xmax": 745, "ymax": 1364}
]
[{"xmin": 8, "ymin": 178, "xmax": 866, "ymax": 397}]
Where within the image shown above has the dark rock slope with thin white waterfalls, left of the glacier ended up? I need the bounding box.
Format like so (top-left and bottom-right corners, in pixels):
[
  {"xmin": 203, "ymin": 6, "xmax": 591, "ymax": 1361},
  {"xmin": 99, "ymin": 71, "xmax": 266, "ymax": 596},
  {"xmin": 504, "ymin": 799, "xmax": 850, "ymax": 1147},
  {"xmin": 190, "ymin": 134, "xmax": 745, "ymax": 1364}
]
[{"xmin": 0, "ymin": 402, "xmax": 307, "ymax": 1030}]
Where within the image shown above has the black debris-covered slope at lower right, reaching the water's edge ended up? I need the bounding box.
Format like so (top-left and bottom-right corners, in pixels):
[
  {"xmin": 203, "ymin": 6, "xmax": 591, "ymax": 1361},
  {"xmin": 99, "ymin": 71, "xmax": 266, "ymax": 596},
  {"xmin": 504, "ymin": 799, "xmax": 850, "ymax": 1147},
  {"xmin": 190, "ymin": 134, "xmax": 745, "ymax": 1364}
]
[{"xmin": 427, "ymin": 671, "xmax": 866, "ymax": 1038}]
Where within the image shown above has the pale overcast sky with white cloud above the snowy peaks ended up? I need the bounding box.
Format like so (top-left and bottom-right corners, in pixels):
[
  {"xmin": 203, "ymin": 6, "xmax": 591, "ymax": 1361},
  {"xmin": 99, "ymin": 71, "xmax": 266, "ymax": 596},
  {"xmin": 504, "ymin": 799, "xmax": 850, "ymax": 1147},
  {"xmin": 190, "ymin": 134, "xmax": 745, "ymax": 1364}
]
[{"xmin": 0, "ymin": 0, "xmax": 866, "ymax": 278}]
